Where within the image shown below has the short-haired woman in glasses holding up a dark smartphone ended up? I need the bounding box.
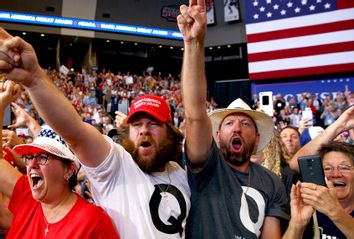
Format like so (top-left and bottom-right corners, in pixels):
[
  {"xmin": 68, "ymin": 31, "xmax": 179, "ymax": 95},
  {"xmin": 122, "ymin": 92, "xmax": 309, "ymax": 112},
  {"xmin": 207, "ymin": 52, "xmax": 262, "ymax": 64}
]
[{"xmin": 283, "ymin": 142, "xmax": 354, "ymax": 239}]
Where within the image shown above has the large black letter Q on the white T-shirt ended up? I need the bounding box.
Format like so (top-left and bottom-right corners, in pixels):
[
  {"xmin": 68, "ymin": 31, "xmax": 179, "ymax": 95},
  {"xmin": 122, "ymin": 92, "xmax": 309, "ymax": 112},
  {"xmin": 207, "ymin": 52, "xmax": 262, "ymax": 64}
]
[{"xmin": 150, "ymin": 184, "xmax": 187, "ymax": 236}]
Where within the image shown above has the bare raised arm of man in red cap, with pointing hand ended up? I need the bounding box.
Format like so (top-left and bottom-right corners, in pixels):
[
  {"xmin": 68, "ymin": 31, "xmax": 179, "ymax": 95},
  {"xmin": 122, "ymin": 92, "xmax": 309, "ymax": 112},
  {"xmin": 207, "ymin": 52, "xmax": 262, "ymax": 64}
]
[{"xmin": 0, "ymin": 28, "xmax": 109, "ymax": 167}]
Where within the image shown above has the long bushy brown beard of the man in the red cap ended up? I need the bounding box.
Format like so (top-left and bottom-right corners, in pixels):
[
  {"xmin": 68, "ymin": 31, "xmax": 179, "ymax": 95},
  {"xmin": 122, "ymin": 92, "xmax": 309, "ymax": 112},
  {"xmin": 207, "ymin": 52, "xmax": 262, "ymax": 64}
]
[{"xmin": 121, "ymin": 136, "xmax": 178, "ymax": 173}]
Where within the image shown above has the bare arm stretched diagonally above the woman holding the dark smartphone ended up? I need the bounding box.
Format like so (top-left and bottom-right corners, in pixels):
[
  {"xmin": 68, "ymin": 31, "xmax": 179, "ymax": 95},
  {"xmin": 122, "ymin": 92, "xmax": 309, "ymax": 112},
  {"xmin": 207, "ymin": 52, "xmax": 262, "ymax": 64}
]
[{"xmin": 290, "ymin": 106, "xmax": 354, "ymax": 172}]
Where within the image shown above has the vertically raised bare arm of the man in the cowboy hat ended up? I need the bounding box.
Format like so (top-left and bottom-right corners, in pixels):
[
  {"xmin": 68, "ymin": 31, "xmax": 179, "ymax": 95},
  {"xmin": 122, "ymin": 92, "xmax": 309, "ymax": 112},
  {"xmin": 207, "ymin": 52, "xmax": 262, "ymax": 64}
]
[{"xmin": 177, "ymin": 0, "xmax": 212, "ymax": 166}]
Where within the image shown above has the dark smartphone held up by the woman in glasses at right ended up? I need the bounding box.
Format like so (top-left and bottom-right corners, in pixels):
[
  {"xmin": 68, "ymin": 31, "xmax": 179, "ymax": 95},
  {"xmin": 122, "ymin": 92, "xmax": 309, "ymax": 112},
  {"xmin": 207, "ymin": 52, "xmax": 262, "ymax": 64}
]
[{"xmin": 297, "ymin": 155, "xmax": 327, "ymax": 187}]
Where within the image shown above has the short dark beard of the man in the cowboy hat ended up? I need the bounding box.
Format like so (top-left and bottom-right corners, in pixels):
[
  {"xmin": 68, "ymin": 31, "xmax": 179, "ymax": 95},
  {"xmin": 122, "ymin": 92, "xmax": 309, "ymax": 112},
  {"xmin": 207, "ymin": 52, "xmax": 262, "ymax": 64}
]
[{"xmin": 219, "ymin": 138, "xmax": 254, "ymax": 166}]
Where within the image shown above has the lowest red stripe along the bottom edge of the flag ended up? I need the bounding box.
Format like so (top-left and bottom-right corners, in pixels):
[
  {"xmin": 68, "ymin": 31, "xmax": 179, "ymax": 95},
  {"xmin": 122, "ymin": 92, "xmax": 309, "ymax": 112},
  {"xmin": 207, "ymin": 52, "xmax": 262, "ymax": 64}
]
[{"xmin": 249, "ymin": 63, "xmax": 354, "ymax": 80}]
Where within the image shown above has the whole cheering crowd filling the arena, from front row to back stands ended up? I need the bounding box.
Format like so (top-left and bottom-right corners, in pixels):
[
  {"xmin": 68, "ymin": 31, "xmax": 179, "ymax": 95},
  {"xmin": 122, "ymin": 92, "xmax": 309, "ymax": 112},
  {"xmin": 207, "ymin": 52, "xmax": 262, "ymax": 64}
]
[{"xmin": 0, "ymin": 0, "xmax": 354, "ymax": 239}]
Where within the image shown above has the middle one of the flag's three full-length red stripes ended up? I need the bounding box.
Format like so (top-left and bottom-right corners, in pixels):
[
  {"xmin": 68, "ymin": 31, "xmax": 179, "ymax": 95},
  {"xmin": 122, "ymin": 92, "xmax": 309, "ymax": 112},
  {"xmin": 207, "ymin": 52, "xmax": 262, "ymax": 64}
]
[{"xmin": 248, "ymin": 42, "xmax": 354, "ymax": 61}]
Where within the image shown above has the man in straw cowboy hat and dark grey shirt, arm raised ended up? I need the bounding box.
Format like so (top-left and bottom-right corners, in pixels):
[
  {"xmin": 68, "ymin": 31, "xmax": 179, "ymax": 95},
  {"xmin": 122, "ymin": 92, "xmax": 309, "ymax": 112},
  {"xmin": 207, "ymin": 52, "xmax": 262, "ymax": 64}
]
[{"xmin": 177, "ymin": 0, "xmax": 288, "ymax": 239}]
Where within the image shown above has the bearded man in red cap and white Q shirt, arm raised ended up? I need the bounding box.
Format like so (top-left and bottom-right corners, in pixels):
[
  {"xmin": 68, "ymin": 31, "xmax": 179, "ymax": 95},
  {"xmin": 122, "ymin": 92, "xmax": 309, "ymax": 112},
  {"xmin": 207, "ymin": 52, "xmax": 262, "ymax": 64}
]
[{"xmin": 0, "ymin": 28, "xmax": 191, "ymax": 239}]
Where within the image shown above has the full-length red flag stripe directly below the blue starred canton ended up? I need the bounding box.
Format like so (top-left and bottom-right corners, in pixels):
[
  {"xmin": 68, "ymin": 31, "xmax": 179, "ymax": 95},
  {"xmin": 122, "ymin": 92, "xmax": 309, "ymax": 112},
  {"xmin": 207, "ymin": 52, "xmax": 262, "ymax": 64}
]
[{"xmin": 247, "ymin": 19, "xmax": 354, "ymax": 43}]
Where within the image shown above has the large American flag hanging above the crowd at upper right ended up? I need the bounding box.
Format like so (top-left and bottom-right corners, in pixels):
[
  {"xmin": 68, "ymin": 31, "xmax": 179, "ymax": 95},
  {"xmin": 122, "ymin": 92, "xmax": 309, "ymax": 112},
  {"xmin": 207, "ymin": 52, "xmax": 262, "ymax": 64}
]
[{"xmin": 245, "ymin": 0, "xmax": 354, "ymax": 80}]
